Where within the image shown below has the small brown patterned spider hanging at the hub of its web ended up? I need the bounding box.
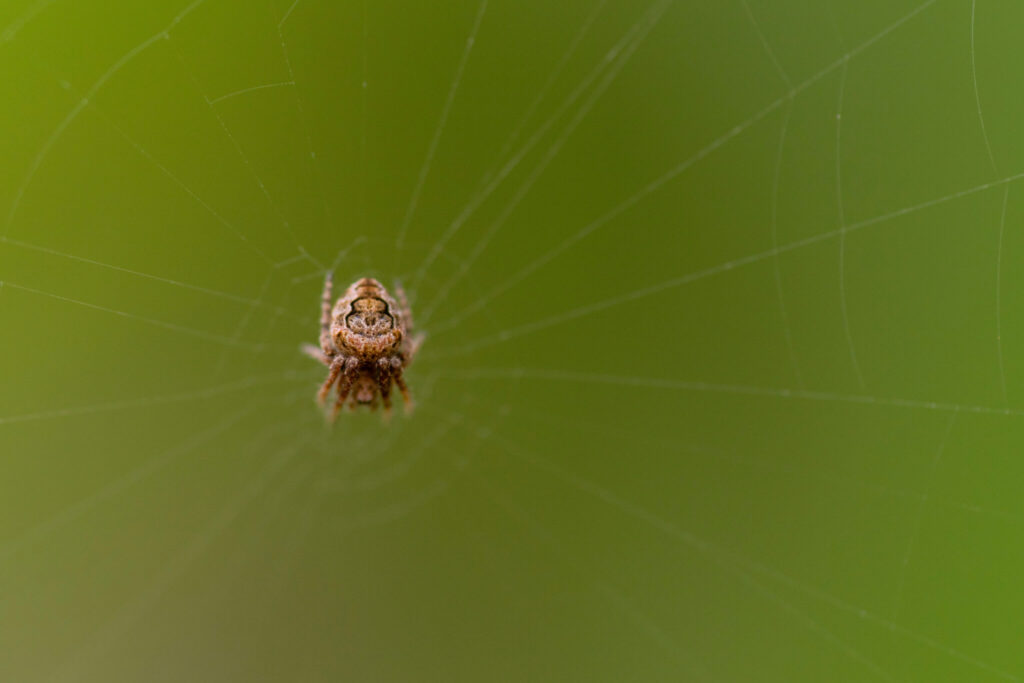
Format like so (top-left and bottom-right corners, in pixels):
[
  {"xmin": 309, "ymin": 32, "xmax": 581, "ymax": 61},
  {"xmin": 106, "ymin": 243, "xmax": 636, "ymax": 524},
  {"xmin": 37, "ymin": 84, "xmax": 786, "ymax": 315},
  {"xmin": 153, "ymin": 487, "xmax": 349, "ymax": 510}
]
[{"xmin": 302, "ymin": 272, "xmax": 422, "ymax": 421}]
